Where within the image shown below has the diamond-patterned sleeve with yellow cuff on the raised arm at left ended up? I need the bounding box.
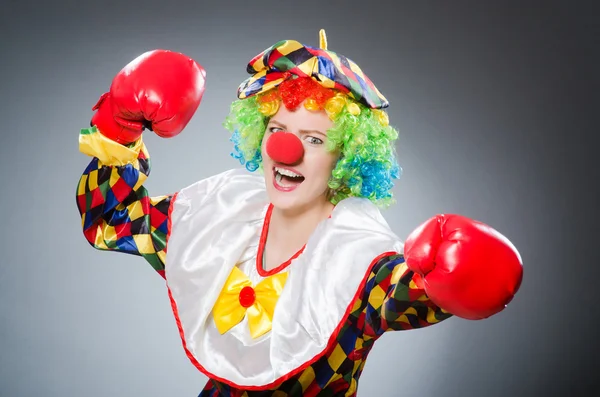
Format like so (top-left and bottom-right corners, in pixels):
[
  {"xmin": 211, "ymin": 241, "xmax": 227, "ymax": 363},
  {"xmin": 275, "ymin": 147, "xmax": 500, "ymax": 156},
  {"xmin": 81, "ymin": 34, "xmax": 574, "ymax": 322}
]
[{"xmin": 77, "ymin": 127, "xmax": 172, "ymax": 277}]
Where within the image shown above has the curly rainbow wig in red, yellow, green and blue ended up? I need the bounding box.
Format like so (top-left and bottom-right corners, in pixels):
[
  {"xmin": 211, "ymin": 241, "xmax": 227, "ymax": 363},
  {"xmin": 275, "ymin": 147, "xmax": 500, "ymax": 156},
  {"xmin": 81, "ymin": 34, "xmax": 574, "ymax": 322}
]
[{"xmin": 224, "ymin": 77, "xmax": 400, "ymax": 207}]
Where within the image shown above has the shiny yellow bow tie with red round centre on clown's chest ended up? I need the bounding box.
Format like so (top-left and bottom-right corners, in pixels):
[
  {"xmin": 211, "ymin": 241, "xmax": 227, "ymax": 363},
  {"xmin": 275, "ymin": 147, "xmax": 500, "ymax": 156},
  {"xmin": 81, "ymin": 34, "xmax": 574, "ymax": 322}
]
[{"xmin": 213, "ymin": 267, "xmax": 287, "ymax": 338}]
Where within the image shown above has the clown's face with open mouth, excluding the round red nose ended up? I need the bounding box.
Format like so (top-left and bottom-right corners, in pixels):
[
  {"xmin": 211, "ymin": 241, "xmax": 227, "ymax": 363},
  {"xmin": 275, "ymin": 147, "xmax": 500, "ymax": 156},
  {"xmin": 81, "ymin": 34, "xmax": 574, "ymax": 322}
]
[{"xmin": 261, "ymin": 104, "xmax": 338, "ymax": 213}]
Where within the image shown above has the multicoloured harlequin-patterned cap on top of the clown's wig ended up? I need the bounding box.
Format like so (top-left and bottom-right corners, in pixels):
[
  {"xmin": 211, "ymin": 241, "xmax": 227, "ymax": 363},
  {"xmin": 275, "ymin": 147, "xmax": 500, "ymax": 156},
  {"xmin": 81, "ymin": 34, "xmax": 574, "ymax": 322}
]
[{"xmin": 238, "ymin": 29, "xmax": 389, "ymax": 109}]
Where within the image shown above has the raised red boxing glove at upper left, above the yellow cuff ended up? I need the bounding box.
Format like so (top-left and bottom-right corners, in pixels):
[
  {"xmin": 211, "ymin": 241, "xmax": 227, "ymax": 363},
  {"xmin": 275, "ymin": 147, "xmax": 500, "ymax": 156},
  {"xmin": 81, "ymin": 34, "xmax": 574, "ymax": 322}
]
[{"xmin": 91, "ymin": 50, "xmax": 206, "ymax": 144}]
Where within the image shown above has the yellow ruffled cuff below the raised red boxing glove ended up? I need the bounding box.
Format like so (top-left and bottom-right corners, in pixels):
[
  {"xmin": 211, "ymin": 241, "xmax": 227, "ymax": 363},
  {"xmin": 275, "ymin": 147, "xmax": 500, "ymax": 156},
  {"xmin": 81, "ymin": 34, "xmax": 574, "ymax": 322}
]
[{"xmin": 79, "ymin": 127, "xmax": 144, "ymax": 166}]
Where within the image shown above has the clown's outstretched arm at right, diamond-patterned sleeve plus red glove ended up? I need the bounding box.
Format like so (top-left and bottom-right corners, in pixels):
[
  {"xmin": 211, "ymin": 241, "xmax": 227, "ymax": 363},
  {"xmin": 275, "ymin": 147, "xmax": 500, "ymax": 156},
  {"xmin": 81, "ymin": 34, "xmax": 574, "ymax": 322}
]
[{"xmin": 365, "ymin": 215, "xmax": 523, "ymax": 336}]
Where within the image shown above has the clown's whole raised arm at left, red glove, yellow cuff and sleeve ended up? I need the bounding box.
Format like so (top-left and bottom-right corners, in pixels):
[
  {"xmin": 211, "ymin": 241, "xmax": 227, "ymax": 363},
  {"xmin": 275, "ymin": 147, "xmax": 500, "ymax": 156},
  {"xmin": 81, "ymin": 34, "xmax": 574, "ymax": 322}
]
[{"xmin": 77, "ymin": 50, "xmax": 205, "ymax": 277}]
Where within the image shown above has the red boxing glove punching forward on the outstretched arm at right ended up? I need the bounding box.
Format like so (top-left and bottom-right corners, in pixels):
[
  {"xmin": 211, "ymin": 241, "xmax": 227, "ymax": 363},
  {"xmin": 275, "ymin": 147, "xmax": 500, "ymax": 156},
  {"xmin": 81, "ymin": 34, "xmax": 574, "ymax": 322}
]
[{"xmin": 404, "ymin": 215, "xmax": 523, "ymax": 320}]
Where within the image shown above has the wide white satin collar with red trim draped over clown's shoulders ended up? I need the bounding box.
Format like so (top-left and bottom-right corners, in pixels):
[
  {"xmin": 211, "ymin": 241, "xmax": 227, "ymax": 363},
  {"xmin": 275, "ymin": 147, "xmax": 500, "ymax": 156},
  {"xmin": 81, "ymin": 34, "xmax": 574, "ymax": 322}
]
[{"xmin": 165, "ymin": 169, "xmax": 402, "ymax": 389}]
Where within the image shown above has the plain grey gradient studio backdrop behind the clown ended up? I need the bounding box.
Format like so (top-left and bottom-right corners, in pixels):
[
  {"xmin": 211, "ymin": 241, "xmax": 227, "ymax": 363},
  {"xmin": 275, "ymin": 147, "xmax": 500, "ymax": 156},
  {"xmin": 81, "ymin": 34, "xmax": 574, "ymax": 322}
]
[{"xmin": 0, "ymin": 0, "xmax": 600, "ymax": 397}]
